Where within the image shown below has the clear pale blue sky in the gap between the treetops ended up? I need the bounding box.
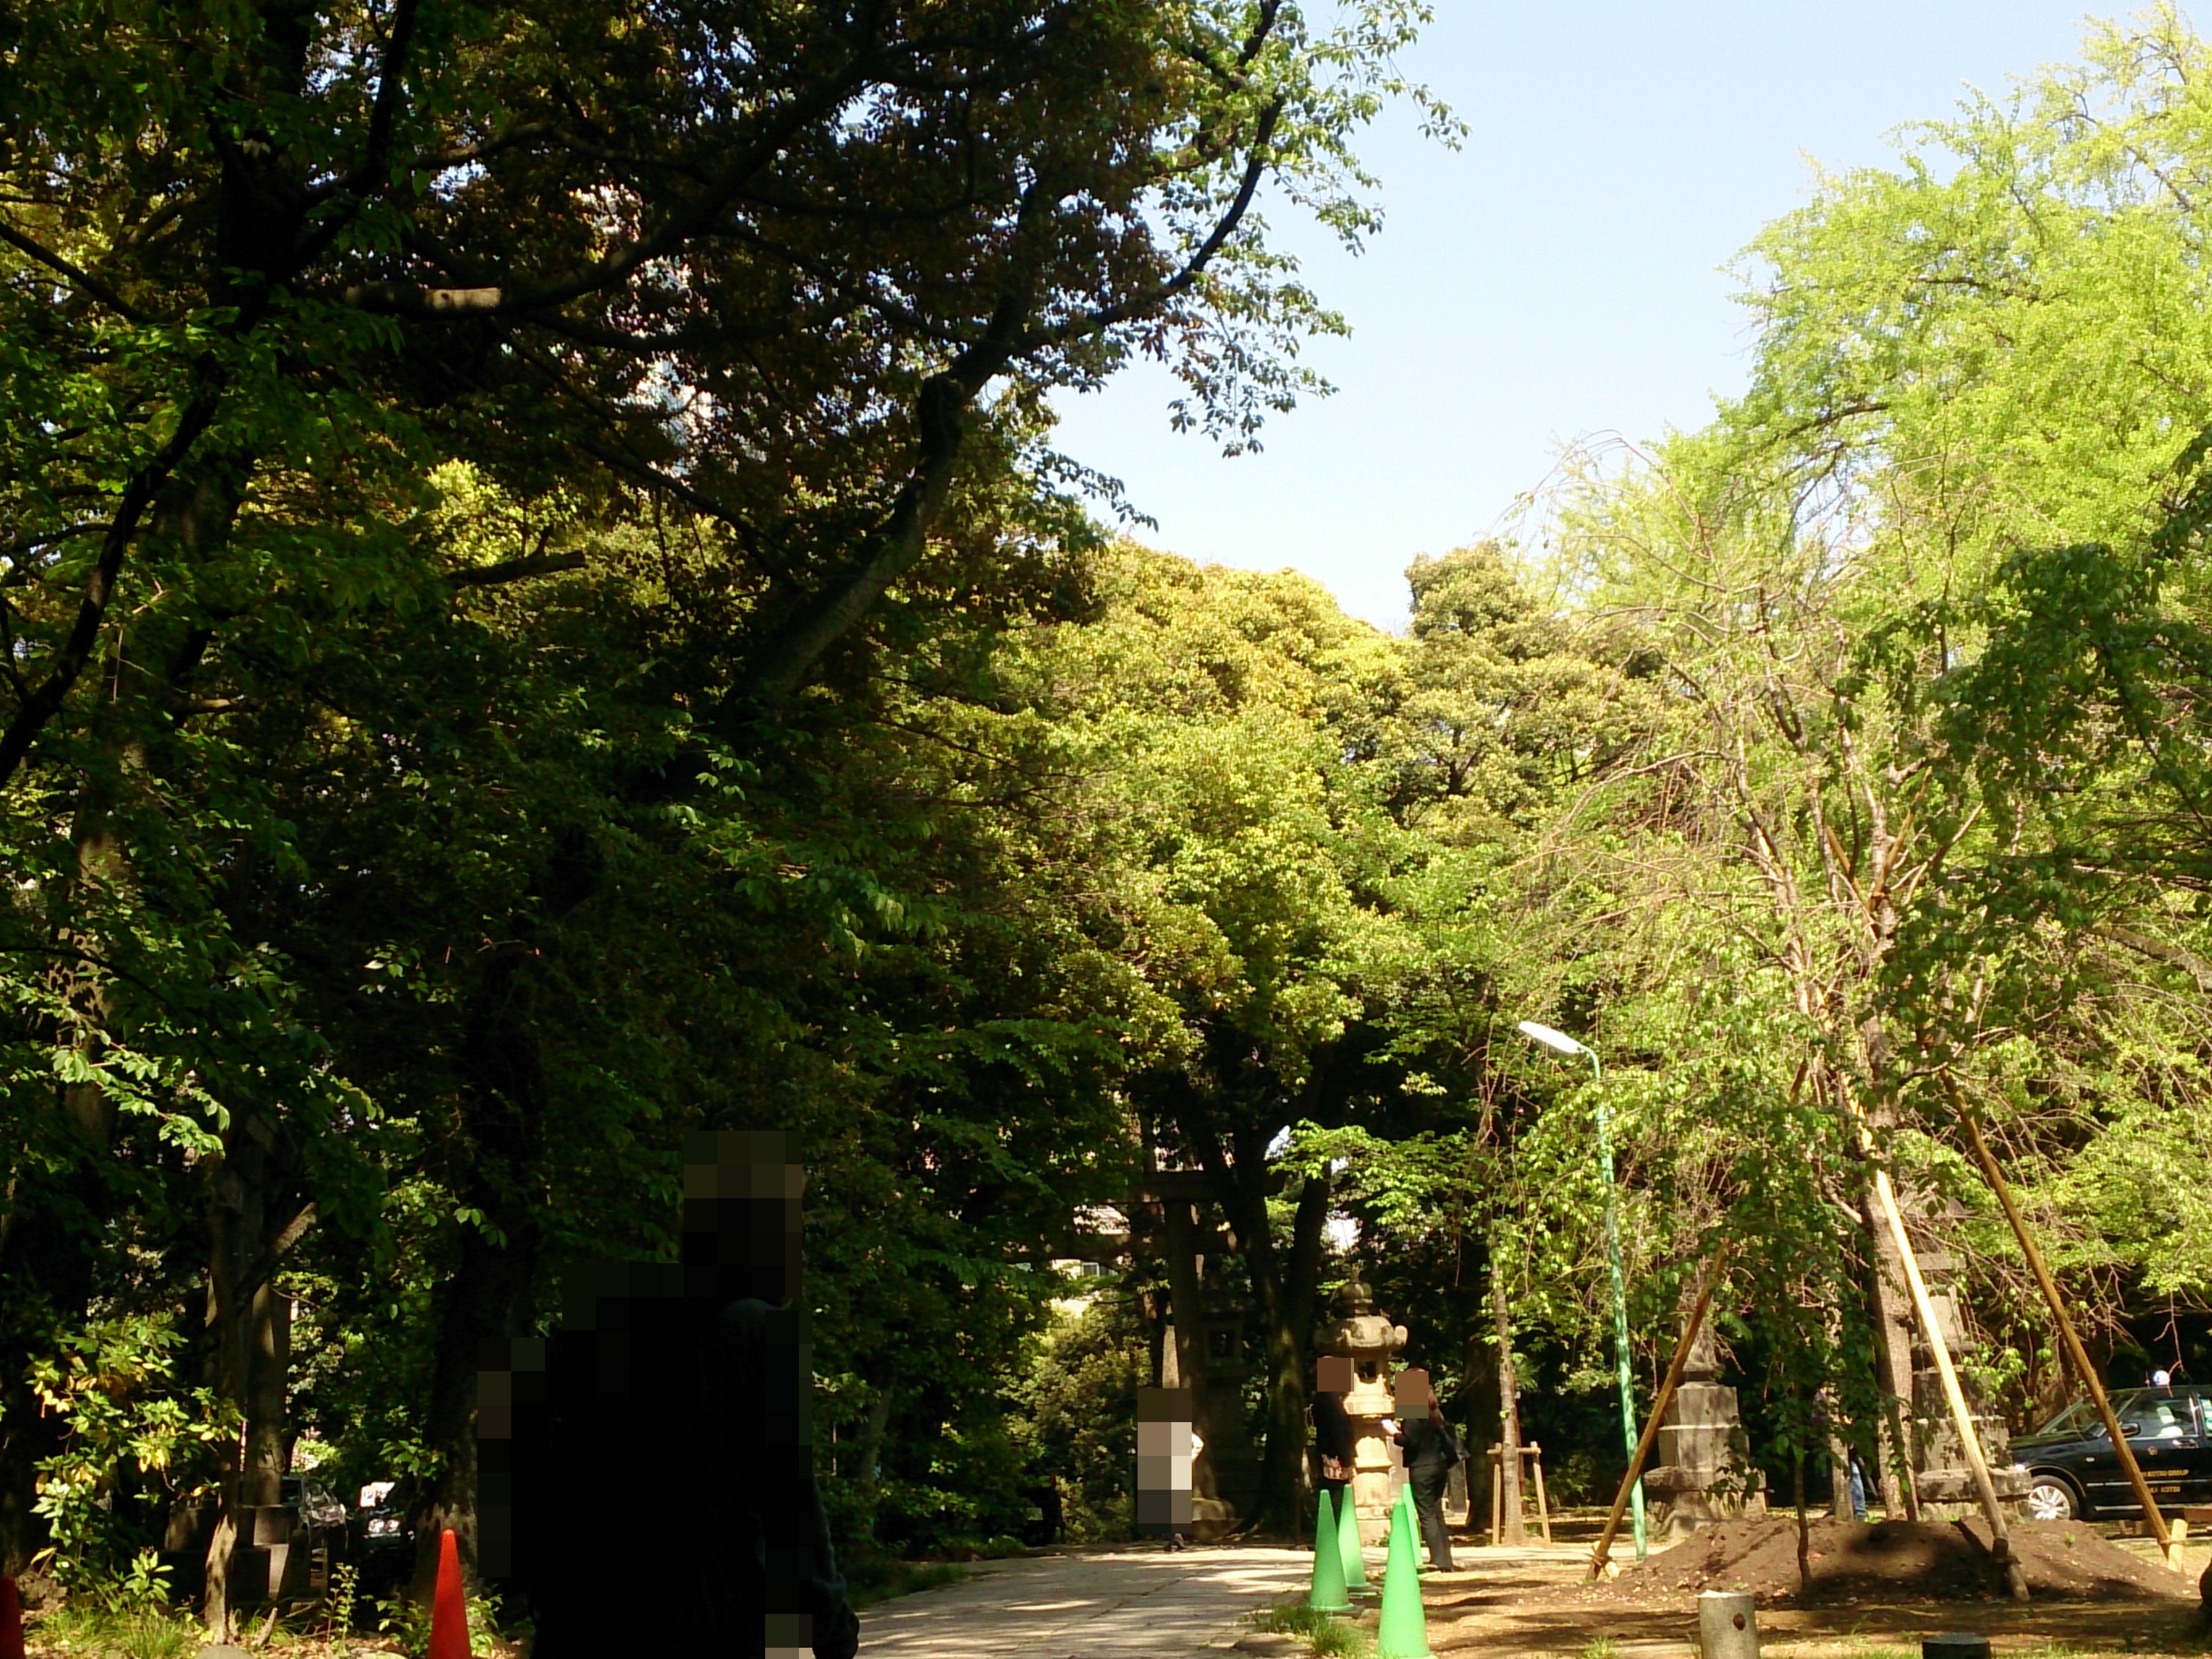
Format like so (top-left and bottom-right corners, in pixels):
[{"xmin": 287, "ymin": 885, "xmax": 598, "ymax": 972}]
[{"xmin": 1059, "ymin": 0, "xmax": 2114, "ymax": 628}]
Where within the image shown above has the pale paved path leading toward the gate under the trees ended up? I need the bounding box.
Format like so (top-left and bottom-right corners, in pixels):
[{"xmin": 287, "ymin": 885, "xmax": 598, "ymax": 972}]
[{"xmin": 861, "ymin": 1546, "xmax": 1309, "ymax": 1659}]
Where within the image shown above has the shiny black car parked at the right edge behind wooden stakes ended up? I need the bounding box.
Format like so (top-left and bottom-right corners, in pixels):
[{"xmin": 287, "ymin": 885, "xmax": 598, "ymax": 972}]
[{"xmin": 2013, "ymin": 1385, "xmax": 2212, "ymax": 1520}]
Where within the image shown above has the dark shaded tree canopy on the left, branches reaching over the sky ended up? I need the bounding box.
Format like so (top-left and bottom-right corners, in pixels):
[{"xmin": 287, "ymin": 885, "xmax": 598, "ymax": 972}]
[{"xmin": 0, "ymin": 0, "xmax": 1445, "ymax": 1626}]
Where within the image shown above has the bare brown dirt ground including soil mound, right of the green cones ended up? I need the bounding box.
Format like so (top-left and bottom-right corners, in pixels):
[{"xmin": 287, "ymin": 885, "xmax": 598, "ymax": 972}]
[{"xmin": 1239, "ymin": 1518, "xmax": 2212, "ymax": 1659}]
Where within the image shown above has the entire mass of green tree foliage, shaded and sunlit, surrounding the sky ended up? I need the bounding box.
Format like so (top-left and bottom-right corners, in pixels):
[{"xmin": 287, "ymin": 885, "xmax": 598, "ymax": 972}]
[{"xmin": 0, "ymin": 0, "xmax": 2212, "ymax": 1626}]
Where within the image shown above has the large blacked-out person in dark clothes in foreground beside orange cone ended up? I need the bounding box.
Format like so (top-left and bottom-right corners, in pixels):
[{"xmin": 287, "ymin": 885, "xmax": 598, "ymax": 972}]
[{"xmin": 478, "ymin": 1133, "xmax": 861, "ymax": 1659}]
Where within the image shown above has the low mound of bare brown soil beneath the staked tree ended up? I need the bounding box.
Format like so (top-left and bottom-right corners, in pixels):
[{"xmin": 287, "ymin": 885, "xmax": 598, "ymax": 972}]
[{"xmin": 1584, "ymin": 1515, "xmax": 2194, "ymax": 1606}]
